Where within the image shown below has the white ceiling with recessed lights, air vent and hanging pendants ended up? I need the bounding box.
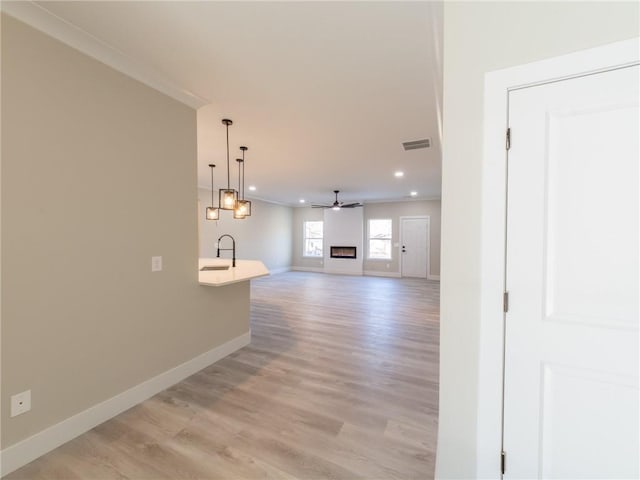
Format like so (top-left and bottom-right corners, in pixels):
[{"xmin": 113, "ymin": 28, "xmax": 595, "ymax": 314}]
[{"xmin": 27, "ymin": 1, "xmax": 442, "ymax": 205}]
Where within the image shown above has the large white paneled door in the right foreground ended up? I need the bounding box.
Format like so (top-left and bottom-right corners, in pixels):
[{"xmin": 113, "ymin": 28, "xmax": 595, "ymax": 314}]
[{"xmin": 503, "ymin": 65, "xmax": 640, "ymax": 479}]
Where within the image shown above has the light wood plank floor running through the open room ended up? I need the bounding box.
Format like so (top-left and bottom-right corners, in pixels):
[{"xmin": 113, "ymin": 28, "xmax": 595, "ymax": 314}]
[{"xmin": 7, "ymin": 272, "xmax": 439, "ymax": 480}]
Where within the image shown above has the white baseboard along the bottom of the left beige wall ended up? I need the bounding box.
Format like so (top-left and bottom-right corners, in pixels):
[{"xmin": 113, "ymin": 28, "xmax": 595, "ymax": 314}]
[{"xmin": 0, "ymin": 330, "xmax": 251, "ymax": 476}]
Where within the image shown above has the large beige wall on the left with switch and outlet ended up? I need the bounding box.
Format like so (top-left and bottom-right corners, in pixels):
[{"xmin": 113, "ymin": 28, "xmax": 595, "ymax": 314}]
[{"xmin": 1, "ymin": 15, "xmax": 249, "ymax": 448}]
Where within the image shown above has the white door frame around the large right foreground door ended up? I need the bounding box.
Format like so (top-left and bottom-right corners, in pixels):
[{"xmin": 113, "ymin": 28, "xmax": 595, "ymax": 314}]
[{"xmin": 476, "ymin": 37, "xmax": 640, "ymax": 478}]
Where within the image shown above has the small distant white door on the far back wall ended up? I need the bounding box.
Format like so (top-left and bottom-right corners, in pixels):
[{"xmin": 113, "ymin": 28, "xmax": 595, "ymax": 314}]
[{"xmin": 400, "ymin": 217, "xmax": 429, "ymax": 278}]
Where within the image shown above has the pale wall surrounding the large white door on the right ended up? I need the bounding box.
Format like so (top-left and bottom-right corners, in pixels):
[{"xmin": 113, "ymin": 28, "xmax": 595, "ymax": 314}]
[{"xmin": 437, "ymin": 2, "xmax": 640, "ymax": 478}]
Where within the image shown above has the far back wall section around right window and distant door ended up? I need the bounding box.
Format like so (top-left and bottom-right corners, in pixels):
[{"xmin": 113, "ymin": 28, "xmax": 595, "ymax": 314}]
[{"xmin": 364, "ymin": 200, "xmax": 440, "ymax": 278}]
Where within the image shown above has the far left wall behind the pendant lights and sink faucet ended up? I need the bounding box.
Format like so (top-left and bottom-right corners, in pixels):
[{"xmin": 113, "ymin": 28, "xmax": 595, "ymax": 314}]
[{"xmin": 198, "ymin": 188, "xmax": 293, "ymax": 272}]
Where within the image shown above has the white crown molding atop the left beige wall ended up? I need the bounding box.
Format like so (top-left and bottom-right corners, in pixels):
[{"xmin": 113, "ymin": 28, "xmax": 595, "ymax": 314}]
[{"xmin": 1, "ymin": 1, "xmax": 211, "ymax": 109}]
